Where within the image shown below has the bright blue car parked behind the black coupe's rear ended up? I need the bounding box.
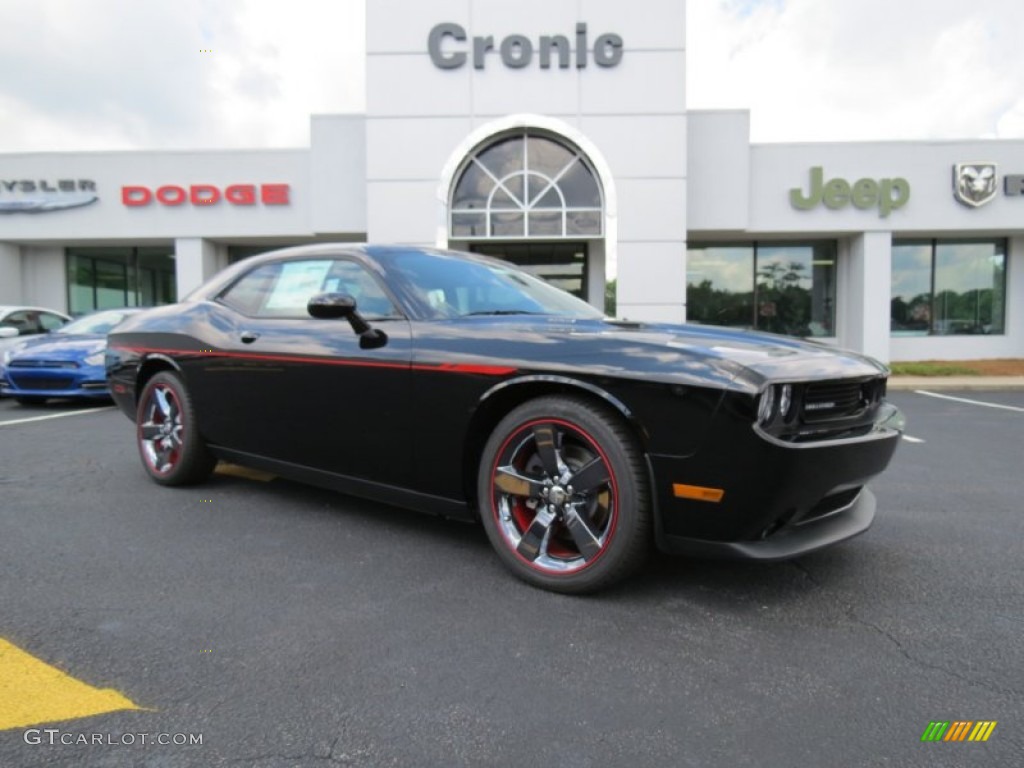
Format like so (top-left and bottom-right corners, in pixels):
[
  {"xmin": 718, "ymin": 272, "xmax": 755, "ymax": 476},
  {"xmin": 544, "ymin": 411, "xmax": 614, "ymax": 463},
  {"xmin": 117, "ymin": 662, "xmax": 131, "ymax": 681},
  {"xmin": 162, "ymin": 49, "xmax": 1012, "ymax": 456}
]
[{"xmin": 0, "ymin": 309, "xmax": 139, "ymax": 406}]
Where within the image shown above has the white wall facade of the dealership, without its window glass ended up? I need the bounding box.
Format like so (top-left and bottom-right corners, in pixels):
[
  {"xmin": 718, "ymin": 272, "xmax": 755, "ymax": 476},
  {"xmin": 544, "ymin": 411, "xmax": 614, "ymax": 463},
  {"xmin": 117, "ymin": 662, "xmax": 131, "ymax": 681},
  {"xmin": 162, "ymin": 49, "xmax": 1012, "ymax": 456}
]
[{"xmin": 0, "ymin": 0, "xmax": 1024, "ymax": 359}]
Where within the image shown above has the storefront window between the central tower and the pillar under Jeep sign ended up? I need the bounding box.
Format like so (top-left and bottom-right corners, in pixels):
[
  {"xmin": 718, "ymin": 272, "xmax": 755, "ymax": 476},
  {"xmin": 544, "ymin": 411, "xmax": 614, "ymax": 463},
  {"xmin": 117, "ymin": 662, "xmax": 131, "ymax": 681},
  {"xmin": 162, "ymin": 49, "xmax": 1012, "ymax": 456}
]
[{"xmin": 686, "ymin": 242, "xmax": 836, "ymax": 337}]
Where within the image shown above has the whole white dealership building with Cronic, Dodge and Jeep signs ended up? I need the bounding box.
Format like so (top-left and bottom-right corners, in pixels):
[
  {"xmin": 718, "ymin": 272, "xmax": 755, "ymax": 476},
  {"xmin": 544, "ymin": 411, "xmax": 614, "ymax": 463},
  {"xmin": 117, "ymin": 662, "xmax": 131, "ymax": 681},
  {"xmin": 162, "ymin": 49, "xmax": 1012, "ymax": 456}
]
[{"xmin": 0, "ymin": 0, "xmax": 1024, "ymax": 360}]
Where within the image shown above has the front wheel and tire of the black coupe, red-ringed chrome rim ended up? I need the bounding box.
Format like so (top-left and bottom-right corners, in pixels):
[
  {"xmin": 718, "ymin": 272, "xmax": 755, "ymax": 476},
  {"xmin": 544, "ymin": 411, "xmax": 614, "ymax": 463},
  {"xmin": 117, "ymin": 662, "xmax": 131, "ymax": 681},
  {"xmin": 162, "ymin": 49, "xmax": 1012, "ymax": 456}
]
[{"xmin": 477, "ymin": 396, "xmax": 651, "ymax": 594}]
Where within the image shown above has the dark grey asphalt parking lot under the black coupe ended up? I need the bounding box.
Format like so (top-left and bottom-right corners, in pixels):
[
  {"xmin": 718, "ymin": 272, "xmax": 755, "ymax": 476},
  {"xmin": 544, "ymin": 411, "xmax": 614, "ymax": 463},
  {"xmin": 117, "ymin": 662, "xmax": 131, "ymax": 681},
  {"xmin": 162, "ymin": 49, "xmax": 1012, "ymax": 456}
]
[{"xmin": 0, "ymin": 391, "xmax": 1024, "ymax": 767}]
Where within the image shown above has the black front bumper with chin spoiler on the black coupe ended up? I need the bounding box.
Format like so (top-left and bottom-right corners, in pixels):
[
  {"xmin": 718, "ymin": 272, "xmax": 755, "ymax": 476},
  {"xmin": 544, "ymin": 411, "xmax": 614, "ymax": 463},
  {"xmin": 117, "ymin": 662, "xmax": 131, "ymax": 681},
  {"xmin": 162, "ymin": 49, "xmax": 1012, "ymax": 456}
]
[{"xmin": 649, "ymin": 407, "xmax": 902, "ymax": 560}]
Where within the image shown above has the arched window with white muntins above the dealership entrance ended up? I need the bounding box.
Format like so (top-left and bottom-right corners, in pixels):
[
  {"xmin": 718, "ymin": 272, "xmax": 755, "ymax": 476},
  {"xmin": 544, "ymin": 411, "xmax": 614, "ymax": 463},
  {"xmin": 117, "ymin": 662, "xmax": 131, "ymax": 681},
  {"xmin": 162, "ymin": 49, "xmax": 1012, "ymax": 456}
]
[{"xmin": 449, "ymin": 131, "xmax": 604, "ymax": 240}]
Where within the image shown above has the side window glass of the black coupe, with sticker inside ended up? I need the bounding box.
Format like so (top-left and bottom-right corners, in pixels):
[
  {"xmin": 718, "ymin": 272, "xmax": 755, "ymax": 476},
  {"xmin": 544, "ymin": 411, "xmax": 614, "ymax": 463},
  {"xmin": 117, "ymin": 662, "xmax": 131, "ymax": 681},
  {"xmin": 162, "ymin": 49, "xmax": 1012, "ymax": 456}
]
[{"xmin": 220, "ymin": 259, "xmax": 398, "ymax": 317}]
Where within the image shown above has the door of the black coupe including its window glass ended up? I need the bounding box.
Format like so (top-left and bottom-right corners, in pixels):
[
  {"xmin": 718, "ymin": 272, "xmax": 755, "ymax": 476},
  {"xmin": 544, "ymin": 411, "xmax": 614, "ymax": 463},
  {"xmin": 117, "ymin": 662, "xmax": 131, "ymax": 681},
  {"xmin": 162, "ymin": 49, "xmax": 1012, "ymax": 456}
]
[{"xmin": 194, "ymin": 257, "xmax": 412, "ymax": 484}]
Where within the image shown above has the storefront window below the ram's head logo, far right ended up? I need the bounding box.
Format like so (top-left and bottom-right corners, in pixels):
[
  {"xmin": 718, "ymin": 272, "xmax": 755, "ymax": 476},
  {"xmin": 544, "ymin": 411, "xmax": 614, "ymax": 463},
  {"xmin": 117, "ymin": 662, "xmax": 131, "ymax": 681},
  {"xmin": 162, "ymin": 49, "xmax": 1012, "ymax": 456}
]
[{"xmin": 890, "ymin": 240, "xmax": 1007, "ymax": 336}]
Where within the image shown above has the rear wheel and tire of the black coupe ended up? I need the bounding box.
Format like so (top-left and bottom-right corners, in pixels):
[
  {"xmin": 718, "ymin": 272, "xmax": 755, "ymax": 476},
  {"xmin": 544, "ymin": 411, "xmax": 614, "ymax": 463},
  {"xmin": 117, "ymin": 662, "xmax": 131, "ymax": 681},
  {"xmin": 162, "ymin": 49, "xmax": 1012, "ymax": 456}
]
[{"xmin": 135, "ymin": 371, "xmax": 217, "ymax": 485}]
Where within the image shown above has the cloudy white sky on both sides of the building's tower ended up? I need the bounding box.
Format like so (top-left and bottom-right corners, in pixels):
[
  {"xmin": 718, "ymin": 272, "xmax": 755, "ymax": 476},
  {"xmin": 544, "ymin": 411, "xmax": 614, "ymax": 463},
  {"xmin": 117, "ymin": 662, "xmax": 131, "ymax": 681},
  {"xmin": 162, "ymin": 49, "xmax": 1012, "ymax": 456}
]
[{"xmin": 0, "ymin": 0, "xmax": 1024, "ymax": 153}]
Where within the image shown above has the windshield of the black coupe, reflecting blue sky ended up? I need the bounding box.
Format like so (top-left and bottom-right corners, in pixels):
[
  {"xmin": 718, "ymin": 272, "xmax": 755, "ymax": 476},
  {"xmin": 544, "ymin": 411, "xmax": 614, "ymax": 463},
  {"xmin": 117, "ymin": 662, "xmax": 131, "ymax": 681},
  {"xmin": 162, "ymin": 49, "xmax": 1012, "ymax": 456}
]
[{"xmin": 390, "ymin": 246, "xmax": 603, "ymax": 318}]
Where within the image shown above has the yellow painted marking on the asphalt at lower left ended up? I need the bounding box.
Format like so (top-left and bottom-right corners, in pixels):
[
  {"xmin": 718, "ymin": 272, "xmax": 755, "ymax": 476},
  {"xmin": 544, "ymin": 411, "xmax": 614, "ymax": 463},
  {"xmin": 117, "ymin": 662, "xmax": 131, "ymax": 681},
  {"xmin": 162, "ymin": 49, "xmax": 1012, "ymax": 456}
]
[{"xmin": 0, "ymin": 638, "xmax": 141, "ymax": 731}]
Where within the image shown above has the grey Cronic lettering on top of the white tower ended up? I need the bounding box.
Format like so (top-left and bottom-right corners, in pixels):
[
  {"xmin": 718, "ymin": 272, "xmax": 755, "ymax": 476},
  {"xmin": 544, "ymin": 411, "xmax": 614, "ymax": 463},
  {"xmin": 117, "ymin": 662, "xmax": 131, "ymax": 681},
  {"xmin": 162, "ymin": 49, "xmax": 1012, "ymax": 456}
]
[{"xmin": 427, "ymin": 22, "xmax": 623, "ymax": 70}]
